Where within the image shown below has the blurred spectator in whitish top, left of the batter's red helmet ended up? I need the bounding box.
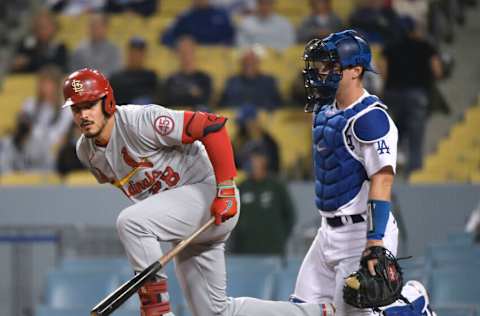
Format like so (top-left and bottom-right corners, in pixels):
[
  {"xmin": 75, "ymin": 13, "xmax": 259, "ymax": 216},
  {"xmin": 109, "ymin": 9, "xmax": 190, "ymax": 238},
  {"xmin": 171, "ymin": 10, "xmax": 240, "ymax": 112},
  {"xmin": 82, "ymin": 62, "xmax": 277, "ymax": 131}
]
[{"xmin": 1, "ymin": 66, "xmax": 72, "ymax": 171}]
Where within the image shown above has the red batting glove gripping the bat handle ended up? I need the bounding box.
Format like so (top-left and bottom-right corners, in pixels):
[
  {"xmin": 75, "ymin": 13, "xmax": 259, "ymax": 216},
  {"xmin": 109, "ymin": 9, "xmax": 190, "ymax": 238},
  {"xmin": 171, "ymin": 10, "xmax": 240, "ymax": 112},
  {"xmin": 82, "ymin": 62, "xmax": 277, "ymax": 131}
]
[{"xmin": 210, "ymin": 184, "xmax": 237, "ymax": 225}]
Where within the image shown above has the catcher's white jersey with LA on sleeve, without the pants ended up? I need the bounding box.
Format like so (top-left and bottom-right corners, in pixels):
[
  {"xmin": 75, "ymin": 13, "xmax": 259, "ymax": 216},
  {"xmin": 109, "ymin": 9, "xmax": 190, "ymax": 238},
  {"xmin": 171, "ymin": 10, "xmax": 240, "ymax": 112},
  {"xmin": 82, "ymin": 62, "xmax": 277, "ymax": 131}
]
[{"xmin": 320, "ymin": 90, "xmax": 398, "ymax": 217}]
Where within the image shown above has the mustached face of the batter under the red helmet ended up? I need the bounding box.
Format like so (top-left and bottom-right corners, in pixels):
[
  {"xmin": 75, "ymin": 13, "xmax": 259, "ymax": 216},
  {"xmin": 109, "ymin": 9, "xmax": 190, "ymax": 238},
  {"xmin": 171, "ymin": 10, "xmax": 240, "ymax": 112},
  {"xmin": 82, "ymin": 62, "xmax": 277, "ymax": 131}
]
[{"xmin": 71, "ymin": 99, "xmax": 107, "ymax": 138}]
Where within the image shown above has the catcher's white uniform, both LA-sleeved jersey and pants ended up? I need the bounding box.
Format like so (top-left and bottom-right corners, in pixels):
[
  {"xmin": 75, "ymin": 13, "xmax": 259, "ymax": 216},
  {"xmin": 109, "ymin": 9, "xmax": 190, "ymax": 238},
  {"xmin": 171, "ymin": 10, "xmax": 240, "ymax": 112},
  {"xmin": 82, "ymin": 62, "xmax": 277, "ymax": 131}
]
[{"xmin": 294, "ymin": 91, "xmax": 398, "ymax": 316}]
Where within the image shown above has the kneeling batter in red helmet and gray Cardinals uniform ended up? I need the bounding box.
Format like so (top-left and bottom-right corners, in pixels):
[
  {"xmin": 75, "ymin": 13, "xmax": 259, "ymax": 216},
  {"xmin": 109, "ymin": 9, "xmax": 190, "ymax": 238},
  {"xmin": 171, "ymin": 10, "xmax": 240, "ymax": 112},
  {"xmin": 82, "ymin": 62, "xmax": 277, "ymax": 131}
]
[{"xmin": 64, "ymin": 69, "xmax": 333, "ymax": 316}]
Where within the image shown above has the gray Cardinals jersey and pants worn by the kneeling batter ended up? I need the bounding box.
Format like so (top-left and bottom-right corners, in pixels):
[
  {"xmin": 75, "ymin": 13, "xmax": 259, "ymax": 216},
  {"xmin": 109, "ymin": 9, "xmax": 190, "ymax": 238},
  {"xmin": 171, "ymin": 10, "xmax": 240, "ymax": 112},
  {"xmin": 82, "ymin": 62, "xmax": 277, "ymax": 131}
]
[{"xmin": 77, "ymin": 105, "xmax": 333, "ymax": 316}]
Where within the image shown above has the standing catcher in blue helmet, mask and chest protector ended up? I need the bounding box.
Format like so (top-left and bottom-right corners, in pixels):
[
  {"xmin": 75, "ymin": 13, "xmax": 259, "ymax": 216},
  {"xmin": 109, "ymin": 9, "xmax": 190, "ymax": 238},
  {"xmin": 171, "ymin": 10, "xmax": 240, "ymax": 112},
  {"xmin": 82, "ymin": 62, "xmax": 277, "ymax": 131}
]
[{"xmin": 291, "ymin": 30, "xmax": 436, "ymax": 316}]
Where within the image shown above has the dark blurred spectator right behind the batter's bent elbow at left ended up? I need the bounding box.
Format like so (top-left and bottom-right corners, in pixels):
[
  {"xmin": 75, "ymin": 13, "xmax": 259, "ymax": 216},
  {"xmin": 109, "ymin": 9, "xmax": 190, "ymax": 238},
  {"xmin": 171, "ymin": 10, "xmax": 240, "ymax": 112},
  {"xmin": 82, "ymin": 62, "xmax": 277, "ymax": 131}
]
[{"xmin": 55, "ymin": 124, "xmax": 86, "ymax": 177}]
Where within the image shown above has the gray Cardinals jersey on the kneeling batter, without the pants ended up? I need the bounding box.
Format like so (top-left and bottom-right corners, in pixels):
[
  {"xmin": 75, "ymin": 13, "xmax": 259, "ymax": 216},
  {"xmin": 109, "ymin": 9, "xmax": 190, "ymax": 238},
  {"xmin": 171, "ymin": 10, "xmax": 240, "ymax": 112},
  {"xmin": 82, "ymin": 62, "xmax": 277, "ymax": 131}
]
[{"xmin": 77, "ymin": 105, "xmax": 214, "ymax": 202}]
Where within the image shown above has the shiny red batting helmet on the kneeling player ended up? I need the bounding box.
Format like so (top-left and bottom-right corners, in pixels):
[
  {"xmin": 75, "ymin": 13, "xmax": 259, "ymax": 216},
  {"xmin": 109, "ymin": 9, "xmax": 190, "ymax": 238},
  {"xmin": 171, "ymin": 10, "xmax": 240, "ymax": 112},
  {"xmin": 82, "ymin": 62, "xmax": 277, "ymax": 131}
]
[{"xmin": 63, "ymin": 68, "xmax": 116, "ymax": 115}]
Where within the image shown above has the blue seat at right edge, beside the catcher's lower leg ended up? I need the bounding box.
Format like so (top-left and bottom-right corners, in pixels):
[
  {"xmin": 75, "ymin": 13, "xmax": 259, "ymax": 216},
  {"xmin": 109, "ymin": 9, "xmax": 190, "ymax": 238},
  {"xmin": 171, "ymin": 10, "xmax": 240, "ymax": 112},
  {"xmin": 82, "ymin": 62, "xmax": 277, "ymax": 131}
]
[{"xmin": 430, "ymin": 265, "xmax": 480, "ymax": 308}]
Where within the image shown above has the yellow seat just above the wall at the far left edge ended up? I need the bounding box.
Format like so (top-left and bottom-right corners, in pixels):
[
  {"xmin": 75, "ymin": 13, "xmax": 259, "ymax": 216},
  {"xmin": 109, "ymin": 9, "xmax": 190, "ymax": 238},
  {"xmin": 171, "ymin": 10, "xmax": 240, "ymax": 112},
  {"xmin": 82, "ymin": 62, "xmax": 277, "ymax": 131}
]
[{"xmin": 0, "ymin": 172, "xmax": 60, "ymax": 186}]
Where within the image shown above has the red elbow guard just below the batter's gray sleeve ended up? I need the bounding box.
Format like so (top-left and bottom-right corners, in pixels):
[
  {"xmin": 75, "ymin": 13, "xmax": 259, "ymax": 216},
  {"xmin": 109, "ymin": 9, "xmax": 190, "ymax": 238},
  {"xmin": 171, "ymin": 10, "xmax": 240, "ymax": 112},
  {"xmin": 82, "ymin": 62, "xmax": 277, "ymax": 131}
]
[{"xmin": 182, "ymin": 111, "xmax": 227, "ymax": 144}]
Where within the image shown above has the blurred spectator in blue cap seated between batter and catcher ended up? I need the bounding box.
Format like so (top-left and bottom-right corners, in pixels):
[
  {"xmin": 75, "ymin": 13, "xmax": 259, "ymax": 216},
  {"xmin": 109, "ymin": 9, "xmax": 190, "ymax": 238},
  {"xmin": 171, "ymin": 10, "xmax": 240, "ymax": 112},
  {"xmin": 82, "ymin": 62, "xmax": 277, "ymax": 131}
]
[{"xmin": 234, "ymin": 105, "xmax": 280, "ymax": 174}]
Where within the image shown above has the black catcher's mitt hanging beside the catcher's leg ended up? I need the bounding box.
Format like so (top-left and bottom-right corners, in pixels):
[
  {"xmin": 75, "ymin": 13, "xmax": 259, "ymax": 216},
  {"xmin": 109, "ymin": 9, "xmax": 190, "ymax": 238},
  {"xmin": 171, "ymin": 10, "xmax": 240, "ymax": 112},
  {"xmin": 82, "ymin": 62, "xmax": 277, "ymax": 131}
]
[{"xmin": 343, "ymin": 246, "xmax": 403, "ymax": 308}]
